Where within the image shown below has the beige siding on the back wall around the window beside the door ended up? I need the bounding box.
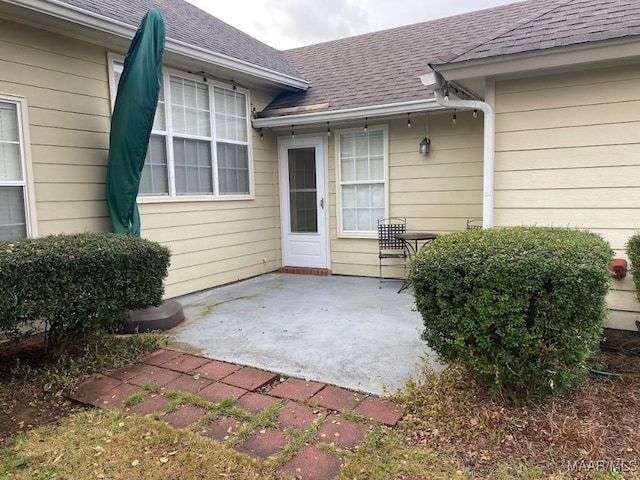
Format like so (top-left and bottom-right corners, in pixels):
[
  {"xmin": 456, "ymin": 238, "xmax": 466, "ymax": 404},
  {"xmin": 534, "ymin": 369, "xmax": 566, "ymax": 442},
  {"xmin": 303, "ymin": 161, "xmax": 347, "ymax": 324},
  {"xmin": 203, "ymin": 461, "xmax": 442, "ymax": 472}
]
[{"xmin": 328, "ymin": 112, "xmax": 483, "ymax": 277}]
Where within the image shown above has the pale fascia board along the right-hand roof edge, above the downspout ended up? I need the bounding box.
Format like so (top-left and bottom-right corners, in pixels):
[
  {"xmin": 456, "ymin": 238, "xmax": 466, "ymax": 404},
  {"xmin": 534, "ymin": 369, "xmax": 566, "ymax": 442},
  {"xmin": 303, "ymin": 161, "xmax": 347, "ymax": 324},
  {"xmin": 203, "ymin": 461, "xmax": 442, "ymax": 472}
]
[{"xmin": 432, "ymin": 37, "xmax": 640, "ymax": 81}]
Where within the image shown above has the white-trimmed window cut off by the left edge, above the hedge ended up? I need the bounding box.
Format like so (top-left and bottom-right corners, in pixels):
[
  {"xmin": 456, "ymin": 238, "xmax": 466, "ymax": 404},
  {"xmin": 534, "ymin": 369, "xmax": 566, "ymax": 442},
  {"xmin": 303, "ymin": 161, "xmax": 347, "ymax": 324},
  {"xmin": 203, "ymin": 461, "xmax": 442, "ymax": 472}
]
[{"xmin": 0, "ymin": 101, "xmax": 30, "ymax": 240}]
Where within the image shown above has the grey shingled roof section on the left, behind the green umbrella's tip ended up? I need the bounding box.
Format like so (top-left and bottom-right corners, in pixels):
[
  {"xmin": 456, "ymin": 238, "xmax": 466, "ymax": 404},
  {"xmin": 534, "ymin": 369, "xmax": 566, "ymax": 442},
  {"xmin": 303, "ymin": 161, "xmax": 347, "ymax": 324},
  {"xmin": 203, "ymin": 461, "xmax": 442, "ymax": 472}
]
[{"xmin": 61, "ymin": 0, "xmax": 304, "ymax": 80}]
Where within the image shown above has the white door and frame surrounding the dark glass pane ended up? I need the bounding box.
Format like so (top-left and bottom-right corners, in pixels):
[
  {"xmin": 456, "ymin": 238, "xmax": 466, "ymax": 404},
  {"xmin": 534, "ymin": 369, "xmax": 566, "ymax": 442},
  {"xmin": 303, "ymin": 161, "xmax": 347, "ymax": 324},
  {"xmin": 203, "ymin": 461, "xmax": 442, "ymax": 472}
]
[{"xmin": 278, "ymin": 135, "xmax": 329, "ymax": 268}]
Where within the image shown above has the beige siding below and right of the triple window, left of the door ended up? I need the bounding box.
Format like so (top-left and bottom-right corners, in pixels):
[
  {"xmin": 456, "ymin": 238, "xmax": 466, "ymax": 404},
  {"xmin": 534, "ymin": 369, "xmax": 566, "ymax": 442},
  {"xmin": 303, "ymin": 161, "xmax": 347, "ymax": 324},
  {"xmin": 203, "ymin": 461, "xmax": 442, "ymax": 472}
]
[{"xmin": 139, "ymin": 91, "xmax": 282, "ymax": 297}]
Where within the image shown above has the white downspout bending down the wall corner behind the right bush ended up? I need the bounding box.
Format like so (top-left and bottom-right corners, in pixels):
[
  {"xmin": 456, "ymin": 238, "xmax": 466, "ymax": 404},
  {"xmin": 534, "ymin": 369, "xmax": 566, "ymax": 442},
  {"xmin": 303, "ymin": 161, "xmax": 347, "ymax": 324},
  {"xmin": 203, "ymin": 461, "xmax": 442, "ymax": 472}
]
[{"xmin": 420, "ymin": 72, "xmax": 495, "ymax": 228}]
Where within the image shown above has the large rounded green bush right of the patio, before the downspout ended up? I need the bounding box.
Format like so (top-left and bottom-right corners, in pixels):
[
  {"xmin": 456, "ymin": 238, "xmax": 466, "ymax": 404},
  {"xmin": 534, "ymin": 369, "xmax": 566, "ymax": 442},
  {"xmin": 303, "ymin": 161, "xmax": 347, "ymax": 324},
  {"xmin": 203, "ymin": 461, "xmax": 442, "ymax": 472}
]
[{"xmin": 409, "ymin": 227, "xmax": 613, "ymax": 403}]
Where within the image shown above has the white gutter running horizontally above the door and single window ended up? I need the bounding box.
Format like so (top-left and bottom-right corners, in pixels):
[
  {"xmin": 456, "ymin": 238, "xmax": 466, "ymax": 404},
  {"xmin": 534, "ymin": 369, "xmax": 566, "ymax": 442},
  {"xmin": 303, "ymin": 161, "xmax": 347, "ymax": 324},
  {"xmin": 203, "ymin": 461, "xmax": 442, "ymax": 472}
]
[{"xmin": 252, "ymin": 98, "xmax": 443, "ymax": 128}]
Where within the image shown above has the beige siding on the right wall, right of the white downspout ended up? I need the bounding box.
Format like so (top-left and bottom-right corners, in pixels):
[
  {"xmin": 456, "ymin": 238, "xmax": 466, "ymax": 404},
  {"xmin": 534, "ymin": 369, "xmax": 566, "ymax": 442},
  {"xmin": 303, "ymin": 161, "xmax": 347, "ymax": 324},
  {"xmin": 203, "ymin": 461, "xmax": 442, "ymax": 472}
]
[{"xmin": 495, "ymin": 65, "xmax": 640, "ymax": 329}]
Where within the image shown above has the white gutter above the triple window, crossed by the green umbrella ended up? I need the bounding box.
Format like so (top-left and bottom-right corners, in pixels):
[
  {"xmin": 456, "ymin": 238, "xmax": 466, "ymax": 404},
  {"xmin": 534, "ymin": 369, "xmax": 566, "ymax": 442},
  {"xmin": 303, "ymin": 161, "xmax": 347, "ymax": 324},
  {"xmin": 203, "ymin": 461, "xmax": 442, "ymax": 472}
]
[{"xmin": 3, "ymin": 0, "xmax": 309, "ymax": 90}]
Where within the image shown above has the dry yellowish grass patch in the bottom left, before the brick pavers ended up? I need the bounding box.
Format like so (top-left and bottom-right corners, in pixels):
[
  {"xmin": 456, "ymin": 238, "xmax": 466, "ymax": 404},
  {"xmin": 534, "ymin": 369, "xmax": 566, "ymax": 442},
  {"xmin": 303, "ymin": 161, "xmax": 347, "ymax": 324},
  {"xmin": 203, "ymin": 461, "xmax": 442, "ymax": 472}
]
[{"xmin": 0, "ymin": 409, "xmax": 275, "ymax": 480}]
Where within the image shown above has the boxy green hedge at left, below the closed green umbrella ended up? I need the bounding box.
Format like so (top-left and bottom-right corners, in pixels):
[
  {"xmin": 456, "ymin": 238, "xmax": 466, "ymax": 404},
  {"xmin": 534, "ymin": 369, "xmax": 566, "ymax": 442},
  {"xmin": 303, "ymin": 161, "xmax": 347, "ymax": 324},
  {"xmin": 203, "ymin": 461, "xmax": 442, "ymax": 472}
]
[{"xmin": 0, "ymin": 233, "xmax": 170, "ymax": 352}]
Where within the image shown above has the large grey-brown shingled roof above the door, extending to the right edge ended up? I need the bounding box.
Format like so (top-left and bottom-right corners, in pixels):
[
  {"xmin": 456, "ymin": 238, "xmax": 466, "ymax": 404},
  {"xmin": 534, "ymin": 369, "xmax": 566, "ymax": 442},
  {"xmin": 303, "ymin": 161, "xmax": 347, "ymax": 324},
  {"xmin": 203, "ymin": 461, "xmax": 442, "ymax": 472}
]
[{"xmin": 261, "ymin": 0, "xmax": 640, "ymax": 117}]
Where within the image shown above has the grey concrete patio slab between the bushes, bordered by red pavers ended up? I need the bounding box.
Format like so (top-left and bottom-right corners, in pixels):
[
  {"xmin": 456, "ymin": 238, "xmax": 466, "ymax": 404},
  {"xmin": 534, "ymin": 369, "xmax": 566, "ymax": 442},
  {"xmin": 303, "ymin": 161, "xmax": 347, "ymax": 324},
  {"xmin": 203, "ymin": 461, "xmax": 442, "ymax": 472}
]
[{"xmin": 168, "ymin": 273, "xmax": 444, "ymax": 395}]
